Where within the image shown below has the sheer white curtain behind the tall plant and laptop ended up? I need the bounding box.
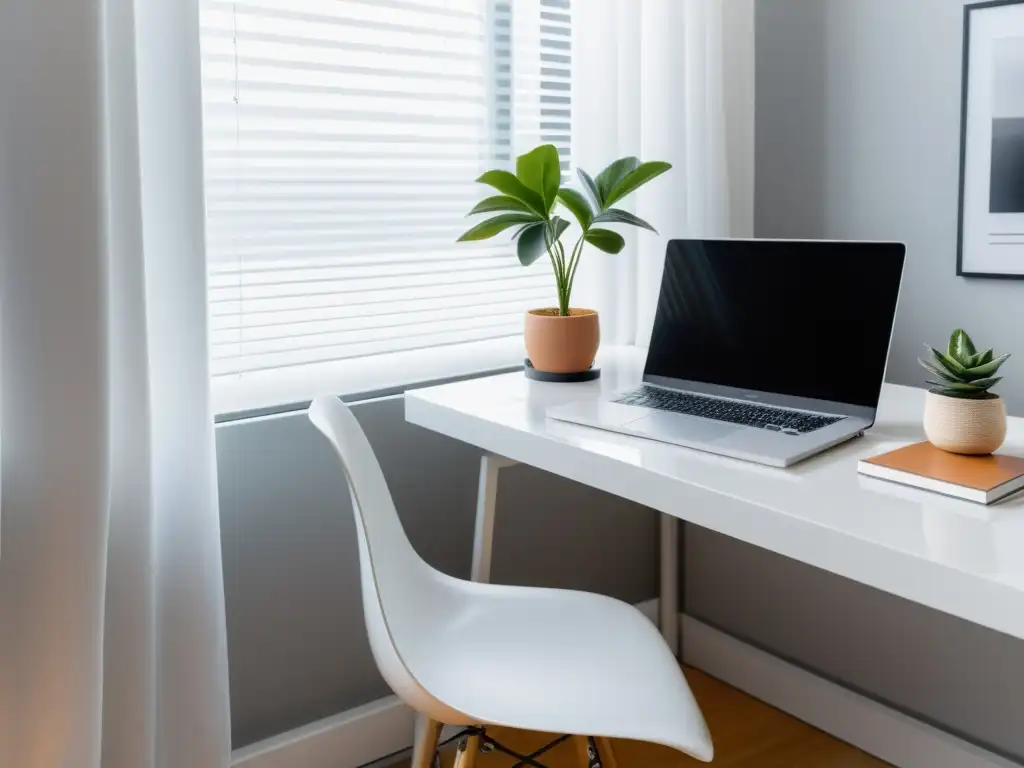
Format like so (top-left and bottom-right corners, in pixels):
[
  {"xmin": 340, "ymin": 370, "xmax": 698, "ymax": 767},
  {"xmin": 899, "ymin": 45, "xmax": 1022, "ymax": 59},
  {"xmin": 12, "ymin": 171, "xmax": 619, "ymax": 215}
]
[{"xmin": 572, "ymin": 0, "xmax": 754, "ymax": 346}]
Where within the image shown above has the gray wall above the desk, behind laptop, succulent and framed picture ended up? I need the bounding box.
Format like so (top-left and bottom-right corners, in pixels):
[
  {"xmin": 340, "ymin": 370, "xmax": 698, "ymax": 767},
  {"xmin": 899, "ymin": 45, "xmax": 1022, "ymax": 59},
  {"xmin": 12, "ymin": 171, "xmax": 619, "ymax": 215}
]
[{"xmin": 755, "ymin": 0, "xmax": 1024, "ymax": 415}]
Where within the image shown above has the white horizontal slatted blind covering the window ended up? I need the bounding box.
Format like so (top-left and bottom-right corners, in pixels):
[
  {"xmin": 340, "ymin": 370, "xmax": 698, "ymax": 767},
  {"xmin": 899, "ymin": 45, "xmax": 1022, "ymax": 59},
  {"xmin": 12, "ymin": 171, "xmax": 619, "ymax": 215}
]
[{"xmin": 201, "ymin": 0, "xmax": 571, "ymax": 377}]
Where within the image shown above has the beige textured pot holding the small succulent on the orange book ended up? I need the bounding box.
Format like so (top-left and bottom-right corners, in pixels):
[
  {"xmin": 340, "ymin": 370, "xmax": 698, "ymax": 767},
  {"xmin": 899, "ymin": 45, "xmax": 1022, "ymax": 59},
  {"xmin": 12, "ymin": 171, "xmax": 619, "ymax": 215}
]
[{"xmin": 925, "ymin": 392, "xmax": 1007, "ymax": 455}]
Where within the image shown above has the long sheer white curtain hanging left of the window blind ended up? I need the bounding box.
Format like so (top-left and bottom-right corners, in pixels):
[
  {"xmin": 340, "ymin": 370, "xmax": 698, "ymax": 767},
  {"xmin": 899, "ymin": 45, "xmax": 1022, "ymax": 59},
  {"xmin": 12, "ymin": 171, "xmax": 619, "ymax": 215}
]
[{"xmin": 0, "ymin": 0, "xmax": 230, "ymax": 768}]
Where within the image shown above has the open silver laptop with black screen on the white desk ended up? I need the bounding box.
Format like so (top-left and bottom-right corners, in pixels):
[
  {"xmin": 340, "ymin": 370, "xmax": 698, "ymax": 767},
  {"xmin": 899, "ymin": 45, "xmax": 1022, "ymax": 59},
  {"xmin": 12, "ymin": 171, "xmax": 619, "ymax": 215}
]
[{"xmin": 548, "ymin": 240, "xmax": 906, "ymax": 467}]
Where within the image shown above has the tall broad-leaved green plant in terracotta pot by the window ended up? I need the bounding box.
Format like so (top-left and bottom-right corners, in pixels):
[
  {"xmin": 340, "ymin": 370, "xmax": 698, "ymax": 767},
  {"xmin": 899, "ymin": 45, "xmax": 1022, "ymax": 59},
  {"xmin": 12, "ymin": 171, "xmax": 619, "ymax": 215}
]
[{"xmin": 459, "ymin": 144, "xmax": 672, "ymax": 374}]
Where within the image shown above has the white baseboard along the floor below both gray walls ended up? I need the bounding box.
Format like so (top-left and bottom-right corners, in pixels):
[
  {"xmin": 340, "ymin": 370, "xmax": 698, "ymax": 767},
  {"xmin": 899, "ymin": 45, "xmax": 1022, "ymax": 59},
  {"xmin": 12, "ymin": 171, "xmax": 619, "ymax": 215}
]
[{"xmin": 231, "ymin": 600, "xmax": 1020, "ymax": 768}]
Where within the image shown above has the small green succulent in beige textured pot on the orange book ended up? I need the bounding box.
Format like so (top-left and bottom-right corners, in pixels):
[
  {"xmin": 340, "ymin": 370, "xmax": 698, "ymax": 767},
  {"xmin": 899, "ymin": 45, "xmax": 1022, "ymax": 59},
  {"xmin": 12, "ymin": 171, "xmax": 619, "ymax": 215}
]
[{"xmin": 919, "ymin": 330, "xmax": 1010, "ymax": 454}]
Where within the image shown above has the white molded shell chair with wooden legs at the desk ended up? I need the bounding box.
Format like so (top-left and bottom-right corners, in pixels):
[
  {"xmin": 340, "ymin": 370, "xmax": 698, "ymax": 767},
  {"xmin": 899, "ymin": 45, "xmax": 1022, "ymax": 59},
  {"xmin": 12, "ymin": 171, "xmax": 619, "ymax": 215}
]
[{"xmin": 309, "ymin": 396, "xmax": 713, "ymax": 768}]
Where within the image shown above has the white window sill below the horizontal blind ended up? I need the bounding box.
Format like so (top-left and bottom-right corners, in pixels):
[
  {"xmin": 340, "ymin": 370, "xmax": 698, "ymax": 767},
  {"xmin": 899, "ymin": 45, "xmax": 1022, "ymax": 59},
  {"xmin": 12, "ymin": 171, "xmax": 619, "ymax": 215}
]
[{"xmin": 211, "ymin": 336, "xmax": 524, "ymax": 423}]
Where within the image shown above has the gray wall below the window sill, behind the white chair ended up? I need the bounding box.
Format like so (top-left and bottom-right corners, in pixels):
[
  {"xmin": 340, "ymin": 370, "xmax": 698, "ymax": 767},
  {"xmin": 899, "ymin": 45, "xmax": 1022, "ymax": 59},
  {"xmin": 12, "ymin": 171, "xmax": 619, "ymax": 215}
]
[{"xmin": 217, "ymin": 399, "xmax": 657, "ymax": 749}]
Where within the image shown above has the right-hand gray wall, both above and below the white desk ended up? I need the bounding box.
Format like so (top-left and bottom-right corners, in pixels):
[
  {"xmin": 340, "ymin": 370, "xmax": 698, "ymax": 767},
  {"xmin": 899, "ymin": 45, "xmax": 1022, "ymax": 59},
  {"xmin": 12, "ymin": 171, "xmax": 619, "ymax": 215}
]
[{"xmin": 685, "ymin": 0, "xmax": 1024, "ymax": 759}]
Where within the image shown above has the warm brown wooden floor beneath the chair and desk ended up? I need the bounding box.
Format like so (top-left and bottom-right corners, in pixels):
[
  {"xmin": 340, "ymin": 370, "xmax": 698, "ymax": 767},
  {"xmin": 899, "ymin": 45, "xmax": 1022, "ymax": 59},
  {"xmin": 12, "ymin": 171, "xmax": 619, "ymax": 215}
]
[{"xmin": 391, "ymin": 669, "xmax": 888, "ymax": 768}]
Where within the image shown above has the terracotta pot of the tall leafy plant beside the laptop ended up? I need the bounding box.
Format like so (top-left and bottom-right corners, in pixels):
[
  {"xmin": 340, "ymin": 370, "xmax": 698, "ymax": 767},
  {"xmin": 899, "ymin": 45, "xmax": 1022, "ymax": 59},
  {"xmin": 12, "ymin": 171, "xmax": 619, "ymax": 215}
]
[{"xmin": 525, "ymin": 307, "xmax": 601, "ymax": 374}]
